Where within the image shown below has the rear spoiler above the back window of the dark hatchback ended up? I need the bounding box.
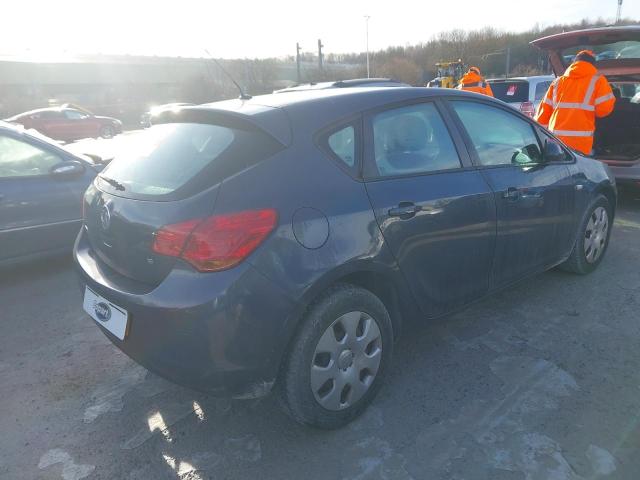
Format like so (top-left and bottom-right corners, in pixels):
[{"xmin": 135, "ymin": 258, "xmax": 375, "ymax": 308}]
[{"xmin": 153, "ymin": 106, "xmax": 292, "ymax": 147}]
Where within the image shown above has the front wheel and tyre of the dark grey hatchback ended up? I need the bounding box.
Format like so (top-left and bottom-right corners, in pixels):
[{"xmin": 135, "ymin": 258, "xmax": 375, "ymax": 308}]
[{"xmin": 560, "ymin": 195, "xmax": 613, "ymax": 275}]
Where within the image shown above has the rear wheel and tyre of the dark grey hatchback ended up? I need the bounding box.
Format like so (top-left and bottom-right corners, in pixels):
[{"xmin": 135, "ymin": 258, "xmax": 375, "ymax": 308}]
[{"xmin": 278, "ymin": 284, "xmax": 393, "ymax": 429}]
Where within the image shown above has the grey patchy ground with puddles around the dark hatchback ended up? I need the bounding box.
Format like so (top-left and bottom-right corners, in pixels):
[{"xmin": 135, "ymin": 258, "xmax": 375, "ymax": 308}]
[{"xmin": 0, "ymin": 189, "xmax": 640, "ymax": 480}]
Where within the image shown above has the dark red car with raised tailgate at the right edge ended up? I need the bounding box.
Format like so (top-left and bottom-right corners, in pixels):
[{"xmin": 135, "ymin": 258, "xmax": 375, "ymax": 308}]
[{"xmin": 532, "ymin": 26, "xmax": 640, "ymax": 187}]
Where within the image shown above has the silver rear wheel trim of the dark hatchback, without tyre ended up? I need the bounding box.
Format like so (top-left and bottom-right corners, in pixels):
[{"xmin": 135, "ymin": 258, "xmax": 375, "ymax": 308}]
[{"xmin": 311, "ymin": 311, "xmax": 382, "ymax": 411}]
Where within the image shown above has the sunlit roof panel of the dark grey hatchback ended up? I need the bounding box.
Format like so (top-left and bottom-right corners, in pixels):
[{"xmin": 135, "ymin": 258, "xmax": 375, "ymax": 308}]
[{"xmin": 181, "ymin": 87, "xmax": 490, "ymax": 145}]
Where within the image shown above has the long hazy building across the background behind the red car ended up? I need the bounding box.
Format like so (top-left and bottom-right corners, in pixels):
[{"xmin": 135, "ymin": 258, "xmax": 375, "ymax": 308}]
[{"xmin": 0, "ymin": 55, "xmax": 354, "ymax": 124}]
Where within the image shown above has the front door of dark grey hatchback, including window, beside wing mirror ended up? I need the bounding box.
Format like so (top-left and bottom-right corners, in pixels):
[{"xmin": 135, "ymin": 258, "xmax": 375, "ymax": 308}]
[{"xmin": 449, "ymin": 99, "xmax": 575, "ymax": 286}]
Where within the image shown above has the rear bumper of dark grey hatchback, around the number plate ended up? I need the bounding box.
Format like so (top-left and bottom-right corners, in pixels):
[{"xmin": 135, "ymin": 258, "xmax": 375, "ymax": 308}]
[{"xmin": 74, "ymin": 230, "xmax": 296, "ymax": 398}]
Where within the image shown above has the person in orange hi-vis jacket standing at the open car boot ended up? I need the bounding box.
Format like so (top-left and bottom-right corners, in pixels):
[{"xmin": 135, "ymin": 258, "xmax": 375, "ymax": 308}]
[{"xmin": 536, "ymin": 50, "xmax": 616, "ymax": 155}]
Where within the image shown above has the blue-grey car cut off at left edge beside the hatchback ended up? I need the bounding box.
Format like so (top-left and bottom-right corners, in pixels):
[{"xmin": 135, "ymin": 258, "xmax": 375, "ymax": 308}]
[{"xmin": 0, "ymin": 122, "xmax": 102, "ymax": 265}]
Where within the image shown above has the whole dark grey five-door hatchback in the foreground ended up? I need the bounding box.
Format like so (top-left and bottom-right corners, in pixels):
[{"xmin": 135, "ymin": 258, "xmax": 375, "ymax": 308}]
[{"xmin": 75, "ymin": 88, "xmax": 616, "ymax": 428}]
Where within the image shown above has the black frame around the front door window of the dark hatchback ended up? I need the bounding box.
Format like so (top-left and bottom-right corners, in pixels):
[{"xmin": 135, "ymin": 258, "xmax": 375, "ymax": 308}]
[{"xmin": 442, "ymin": 96, "xmax": 575, "ymax": 170}]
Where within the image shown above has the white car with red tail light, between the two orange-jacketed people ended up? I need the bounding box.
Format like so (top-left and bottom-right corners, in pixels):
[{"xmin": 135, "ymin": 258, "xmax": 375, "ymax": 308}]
[{"xmin": 488, "ymin": 75, "xmax": 555, "ymax": 118}]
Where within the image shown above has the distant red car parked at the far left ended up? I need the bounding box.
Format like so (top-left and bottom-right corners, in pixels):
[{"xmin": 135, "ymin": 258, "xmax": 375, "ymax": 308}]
[{"xmin": 6, "ymin": 106, "xmax": 122, "ymax": 142}]
